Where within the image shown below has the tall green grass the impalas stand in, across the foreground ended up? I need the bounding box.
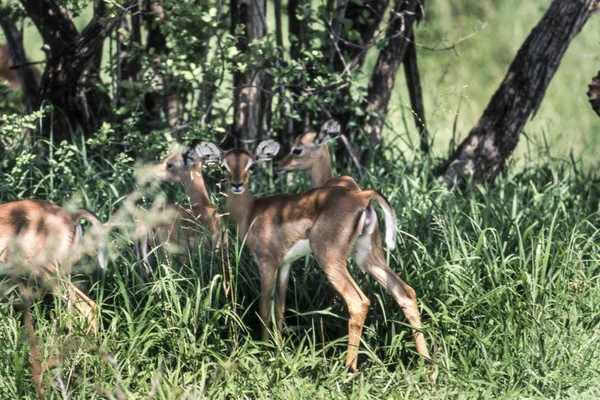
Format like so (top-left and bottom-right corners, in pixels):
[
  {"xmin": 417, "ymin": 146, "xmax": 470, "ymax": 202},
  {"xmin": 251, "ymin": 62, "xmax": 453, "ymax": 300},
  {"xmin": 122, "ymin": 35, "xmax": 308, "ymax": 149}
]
[{"xmin": 0, "ymin": 130, "xmax": 600, "ymax": 399}]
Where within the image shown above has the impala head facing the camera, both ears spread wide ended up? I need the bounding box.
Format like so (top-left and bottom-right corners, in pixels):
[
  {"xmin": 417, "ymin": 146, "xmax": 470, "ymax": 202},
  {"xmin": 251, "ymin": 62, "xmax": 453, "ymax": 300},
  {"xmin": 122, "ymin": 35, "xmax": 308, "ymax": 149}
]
[{"xmin": 196, "ymin": 139, "xmax": 280, "ymax": 194}]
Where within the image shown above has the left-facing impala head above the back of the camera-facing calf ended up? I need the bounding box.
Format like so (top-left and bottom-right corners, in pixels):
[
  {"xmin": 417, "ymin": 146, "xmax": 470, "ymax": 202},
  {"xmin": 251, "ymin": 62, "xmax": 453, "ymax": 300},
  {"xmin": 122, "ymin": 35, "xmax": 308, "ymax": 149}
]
[{"xmin": 277, "ymin": 119, "xmax": 342, "ymax": 174}]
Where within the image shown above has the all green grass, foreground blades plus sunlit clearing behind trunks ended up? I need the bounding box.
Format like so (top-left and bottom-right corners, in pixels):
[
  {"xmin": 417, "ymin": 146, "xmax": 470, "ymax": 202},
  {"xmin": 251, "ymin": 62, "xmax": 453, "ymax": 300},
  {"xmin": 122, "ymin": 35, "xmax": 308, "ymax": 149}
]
[{"xmin": 0, "ymin": 0, "xmax": 600, "ymax": 399}]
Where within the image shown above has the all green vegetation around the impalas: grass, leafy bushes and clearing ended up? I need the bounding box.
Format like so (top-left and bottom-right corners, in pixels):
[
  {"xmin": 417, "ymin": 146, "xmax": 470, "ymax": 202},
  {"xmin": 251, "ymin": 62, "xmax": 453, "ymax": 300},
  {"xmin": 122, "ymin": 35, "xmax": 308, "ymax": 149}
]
[{"xmin": 0, "ymin": 0, "xmax": 600, "ymax": 398}]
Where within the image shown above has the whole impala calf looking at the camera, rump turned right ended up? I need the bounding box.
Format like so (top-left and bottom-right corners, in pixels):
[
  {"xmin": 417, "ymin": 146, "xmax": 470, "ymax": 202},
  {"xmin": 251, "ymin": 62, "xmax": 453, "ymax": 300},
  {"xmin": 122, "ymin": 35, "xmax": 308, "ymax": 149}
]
[{"xmin": 196, "ymin": 140, "xmax": 429, "ymax": 370}]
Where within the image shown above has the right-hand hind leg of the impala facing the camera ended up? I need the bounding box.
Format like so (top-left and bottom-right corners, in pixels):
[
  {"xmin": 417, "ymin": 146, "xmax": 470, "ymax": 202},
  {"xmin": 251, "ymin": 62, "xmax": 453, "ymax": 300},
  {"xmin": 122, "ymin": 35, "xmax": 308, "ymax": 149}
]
[{"xmin": 354, "ymin": 229, "xmax": 430, "ymax": 360}]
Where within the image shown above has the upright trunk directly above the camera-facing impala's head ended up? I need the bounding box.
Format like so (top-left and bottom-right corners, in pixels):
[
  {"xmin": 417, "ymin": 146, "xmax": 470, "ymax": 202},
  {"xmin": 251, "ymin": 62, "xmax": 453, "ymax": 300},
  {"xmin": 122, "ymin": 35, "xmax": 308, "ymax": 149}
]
[{"xmin": 229, "ymin": 0, "xmax": 266, "ymax": 147}]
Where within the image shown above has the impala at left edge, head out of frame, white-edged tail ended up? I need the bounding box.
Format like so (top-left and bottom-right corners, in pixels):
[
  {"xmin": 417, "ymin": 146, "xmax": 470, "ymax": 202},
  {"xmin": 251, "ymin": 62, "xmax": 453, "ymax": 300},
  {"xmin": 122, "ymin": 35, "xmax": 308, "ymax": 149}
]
[{"xmin": 0, "ymin": 200, "xmax": 105, "ymax": 331}]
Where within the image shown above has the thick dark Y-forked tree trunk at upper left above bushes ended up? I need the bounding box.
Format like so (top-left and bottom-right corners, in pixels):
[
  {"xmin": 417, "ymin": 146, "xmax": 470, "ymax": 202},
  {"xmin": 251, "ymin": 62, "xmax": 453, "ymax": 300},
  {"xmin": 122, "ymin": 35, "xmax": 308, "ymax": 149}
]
[{"xmin": 21, "ymin": 0, "xmax": 114, "ymax": 142}]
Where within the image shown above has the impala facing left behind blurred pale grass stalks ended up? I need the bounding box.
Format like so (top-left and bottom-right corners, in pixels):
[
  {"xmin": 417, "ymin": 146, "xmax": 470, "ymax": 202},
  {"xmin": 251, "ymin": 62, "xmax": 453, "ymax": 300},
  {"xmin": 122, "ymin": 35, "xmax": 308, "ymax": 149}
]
[{"xmin": 137, "ymin": 146, "xmax": 226, "ymax": 277}]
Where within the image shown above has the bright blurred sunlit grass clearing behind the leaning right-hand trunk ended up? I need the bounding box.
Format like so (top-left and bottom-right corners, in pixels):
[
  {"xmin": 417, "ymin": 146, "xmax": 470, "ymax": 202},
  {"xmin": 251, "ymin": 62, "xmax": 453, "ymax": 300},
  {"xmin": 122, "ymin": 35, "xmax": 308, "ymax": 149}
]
[{"xmin": 384, "ymin": 0, "xmax": 600, "ymax": 165}]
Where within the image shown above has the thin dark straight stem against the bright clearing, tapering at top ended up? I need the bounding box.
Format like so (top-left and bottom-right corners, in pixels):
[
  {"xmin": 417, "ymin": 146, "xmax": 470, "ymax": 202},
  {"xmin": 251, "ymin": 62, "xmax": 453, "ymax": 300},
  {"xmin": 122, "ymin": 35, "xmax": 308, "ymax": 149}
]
[{"xmin": 402, "ymin": 32, "xmax": 429, "ymax": 154}]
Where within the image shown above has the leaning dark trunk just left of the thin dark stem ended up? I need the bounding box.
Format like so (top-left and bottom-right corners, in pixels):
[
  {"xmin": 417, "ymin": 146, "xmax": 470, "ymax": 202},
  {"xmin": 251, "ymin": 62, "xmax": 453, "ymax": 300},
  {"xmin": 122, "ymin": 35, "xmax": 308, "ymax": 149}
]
[{"xmin": 364, "ymin": 0, "xmax": 422, "ymax": 144}]
